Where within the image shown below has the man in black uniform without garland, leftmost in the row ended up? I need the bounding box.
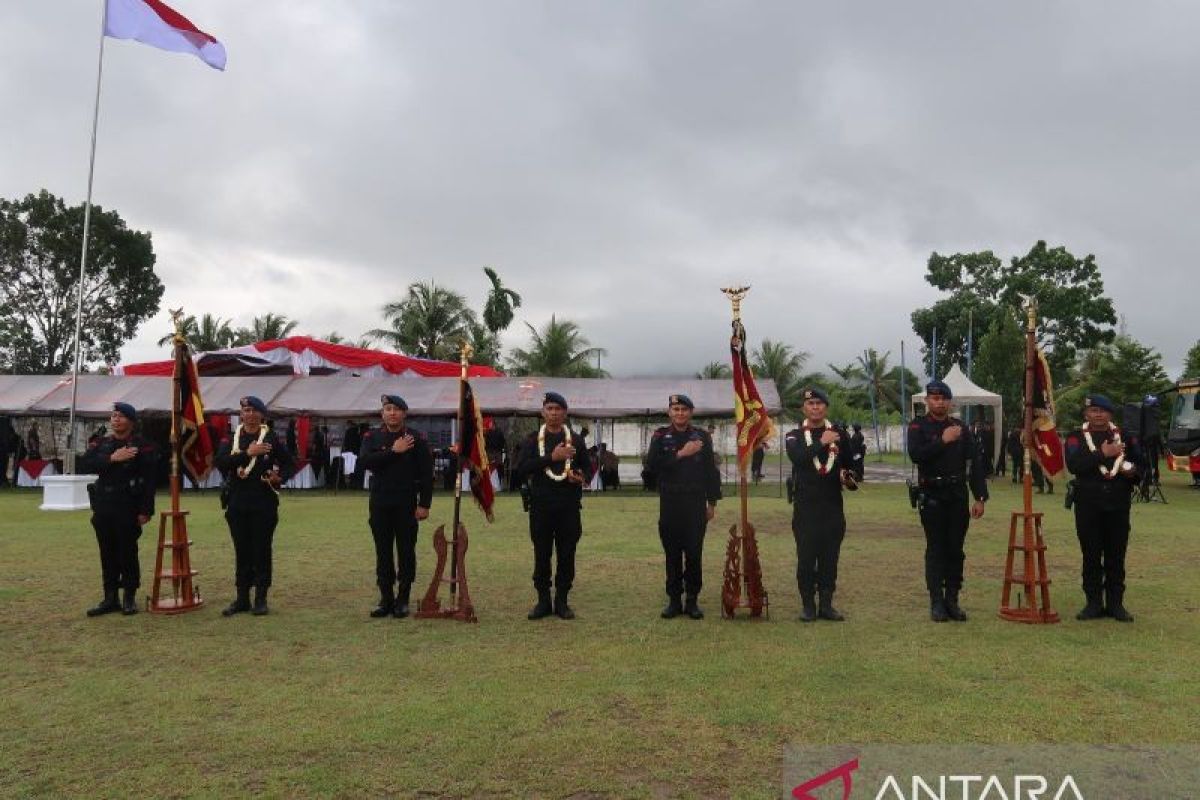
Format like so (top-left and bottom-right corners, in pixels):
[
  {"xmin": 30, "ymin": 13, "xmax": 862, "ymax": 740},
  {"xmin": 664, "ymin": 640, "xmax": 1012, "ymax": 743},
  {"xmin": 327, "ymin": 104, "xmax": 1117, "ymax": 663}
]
[{"xmin": 79, "ymin": 403, "xmax": 157, "ymax": 616}]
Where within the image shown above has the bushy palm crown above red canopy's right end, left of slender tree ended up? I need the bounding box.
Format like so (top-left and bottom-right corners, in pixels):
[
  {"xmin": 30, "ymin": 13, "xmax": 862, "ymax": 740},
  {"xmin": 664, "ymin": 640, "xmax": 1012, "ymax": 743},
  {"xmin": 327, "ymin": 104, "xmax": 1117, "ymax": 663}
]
[{"xmin": 366, "ymin": 281, "xmax": 479, "ymax": 361}]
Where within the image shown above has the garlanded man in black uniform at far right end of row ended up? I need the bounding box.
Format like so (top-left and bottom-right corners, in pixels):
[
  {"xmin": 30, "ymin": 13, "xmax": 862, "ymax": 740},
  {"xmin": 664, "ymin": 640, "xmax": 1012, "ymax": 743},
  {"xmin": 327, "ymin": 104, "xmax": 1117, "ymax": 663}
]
[{"xmin": 1066, "ymin": 395, "xmax": 1144, "ymax": 622}]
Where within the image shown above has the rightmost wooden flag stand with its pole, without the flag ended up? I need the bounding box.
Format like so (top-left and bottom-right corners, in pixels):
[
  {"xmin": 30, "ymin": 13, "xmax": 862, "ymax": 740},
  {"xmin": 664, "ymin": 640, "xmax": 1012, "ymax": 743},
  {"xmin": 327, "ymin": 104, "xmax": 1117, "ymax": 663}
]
[{"xmin": 1000, "ymin": 297, "xmax": 1060, "ymax": 625}]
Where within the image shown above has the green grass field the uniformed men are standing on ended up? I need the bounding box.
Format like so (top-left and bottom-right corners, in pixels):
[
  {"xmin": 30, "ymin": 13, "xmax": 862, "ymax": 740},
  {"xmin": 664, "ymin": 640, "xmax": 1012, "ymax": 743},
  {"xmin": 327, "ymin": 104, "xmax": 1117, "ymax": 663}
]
[{"xmin": 0, "ymin": 476, "xmax": 1200, "ymax": 798}]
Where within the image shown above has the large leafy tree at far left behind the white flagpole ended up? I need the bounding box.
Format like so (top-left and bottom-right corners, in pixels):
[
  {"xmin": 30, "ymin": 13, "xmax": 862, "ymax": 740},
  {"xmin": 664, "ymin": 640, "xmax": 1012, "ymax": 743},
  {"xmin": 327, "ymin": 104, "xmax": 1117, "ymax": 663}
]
[{"xmin": 0, "ymin": 190, "xmax": 163, "ymax": 373}]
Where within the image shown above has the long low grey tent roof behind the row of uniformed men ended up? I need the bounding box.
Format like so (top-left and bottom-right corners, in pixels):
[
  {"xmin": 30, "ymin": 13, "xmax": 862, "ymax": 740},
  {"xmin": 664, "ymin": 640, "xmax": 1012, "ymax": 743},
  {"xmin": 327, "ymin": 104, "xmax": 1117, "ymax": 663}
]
[{"xmin": 0, "ymin": 374, "xmax": 781, "ymax": 419}]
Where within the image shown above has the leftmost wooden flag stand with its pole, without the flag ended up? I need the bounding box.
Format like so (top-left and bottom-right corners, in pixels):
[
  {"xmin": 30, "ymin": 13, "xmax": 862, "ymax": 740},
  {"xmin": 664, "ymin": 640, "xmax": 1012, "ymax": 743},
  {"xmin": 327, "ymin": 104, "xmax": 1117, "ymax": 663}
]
[{"xmin": 148, "ymin": 321, "xmax": 204, "ymax": 614}]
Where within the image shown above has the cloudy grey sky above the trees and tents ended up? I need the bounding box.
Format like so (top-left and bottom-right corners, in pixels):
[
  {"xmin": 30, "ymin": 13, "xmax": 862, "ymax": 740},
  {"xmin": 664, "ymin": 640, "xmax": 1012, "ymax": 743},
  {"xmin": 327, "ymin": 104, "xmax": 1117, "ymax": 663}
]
[{"xmin": 0, "ymin": 0, "xmax": 1200, "ymax": 375}]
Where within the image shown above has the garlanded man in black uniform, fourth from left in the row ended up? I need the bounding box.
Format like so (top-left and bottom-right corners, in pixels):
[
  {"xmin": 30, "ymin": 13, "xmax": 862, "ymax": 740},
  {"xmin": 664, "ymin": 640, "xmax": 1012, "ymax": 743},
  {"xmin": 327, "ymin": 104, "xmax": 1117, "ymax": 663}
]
[{"xmin": 517, "ymin": 392, "xmax": 592, "ymax": 619}]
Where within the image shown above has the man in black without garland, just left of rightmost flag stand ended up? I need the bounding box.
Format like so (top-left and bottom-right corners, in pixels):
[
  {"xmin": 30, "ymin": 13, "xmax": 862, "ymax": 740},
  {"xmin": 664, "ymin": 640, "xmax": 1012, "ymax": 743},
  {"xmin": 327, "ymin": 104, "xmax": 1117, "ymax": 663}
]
[{"xmin": 908, "ymin": 380, "xmax": 988, "ymax": 622}]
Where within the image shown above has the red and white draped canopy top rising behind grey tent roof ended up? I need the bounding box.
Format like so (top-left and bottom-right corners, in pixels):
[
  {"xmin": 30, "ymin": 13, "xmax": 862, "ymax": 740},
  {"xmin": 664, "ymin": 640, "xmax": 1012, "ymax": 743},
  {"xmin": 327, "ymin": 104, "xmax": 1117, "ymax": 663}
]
[{"xmin": 113, "ymin": 336, "xmax": 500, "ymax": 378}]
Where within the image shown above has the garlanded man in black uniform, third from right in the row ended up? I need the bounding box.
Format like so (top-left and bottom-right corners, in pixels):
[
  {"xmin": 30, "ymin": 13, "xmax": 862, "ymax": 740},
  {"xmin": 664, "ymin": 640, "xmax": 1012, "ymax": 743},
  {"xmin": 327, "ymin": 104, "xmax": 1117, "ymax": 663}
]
[{"xmin": 784, "ymin": 389, "xmax": 862, "ymax": 622}]
